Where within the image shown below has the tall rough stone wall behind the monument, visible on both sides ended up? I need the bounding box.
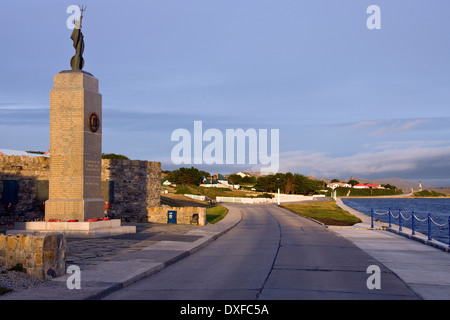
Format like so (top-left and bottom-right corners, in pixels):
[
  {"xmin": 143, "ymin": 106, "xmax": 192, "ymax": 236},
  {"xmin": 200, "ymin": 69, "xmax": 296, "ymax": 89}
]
[{"xmin": 0, "ymin": 156, "xmax": 161, "ymax": 225}]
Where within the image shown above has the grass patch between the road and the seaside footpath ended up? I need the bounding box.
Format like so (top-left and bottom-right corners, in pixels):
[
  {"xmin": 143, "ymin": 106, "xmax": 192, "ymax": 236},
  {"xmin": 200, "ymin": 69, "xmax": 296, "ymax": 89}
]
[{"xmin": 281, "ymin": 201, "xmax": 361, "ymax": 226}]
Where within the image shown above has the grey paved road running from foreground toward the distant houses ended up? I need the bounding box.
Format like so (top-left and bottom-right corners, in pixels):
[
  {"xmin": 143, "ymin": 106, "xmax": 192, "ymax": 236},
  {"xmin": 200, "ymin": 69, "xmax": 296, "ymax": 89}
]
[{"xmin": 105, "ymin": 205, "xmax": 419, "ymax": 300}]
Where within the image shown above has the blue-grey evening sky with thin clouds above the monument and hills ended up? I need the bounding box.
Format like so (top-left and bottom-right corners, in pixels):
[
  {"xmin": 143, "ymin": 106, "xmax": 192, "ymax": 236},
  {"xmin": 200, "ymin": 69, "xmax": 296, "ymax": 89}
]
[{"xmin": 0, "ymin": 0, "xmax": 450, "ymax": 186}]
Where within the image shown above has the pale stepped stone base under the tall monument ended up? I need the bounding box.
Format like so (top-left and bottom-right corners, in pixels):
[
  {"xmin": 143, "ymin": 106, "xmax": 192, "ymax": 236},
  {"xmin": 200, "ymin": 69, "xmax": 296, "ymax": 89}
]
[{"xmin": 7, "ymin": 219, "xmax": 136, "ymax": 238}]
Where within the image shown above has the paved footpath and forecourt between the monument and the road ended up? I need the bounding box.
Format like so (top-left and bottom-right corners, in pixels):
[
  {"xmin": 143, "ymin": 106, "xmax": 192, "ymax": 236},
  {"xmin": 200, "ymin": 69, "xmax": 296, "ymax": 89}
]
[{"xmin": 0, "ymin": 207, "xmax": 242, "ymax": 300}]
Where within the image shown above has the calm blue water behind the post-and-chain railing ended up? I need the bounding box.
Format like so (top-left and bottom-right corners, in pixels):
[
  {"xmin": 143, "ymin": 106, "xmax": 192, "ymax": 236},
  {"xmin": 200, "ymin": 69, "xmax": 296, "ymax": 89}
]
[{"xmin": 342, "ymin": 198, "xmax": 450, "ymax": 244}]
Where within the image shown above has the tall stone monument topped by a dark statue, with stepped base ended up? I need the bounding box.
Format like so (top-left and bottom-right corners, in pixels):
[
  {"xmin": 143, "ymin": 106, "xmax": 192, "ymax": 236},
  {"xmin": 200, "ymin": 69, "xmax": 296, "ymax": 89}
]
[{"xmin": 10, "ymin": 8, "xmax": 136, "ymax": 237}]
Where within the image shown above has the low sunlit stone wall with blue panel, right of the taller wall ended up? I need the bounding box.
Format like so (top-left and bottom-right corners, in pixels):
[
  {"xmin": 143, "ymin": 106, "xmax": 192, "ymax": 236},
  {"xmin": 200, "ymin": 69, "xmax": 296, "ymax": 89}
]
[{"xmin": 148, "ymin": 206, "xmax": 206, "ymax": 226}]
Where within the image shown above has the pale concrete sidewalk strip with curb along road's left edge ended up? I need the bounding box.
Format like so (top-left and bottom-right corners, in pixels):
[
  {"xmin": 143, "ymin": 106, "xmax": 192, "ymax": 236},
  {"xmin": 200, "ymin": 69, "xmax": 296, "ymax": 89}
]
[{"xmin": 0, "ymin": 206, "xmax": 242, "ymax": 300}]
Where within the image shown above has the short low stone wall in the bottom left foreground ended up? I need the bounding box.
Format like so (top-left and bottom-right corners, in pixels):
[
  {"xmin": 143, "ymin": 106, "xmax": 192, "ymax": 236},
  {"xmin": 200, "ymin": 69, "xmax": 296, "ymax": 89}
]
[{"xmin": 0, "ymin": 234, "xmax": 66, "ymax": 279}]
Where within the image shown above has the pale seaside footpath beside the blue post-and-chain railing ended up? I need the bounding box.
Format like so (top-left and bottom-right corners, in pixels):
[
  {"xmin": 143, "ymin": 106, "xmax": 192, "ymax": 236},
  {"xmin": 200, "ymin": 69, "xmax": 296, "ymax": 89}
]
[{"xmin": 328, "ymin": 198, "xmax": 450, "ymax": 300}]
